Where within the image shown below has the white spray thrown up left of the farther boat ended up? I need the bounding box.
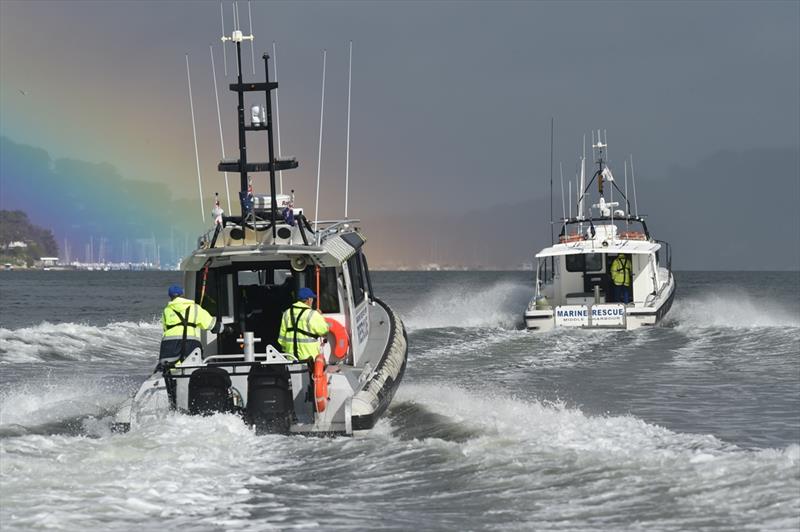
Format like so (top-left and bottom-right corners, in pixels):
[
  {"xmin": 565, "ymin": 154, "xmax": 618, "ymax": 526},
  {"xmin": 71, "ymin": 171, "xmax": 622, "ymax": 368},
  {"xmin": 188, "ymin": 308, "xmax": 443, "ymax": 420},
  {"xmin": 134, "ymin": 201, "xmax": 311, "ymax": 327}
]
[{"xmin": 403, "ymin": 281, "xmax": 533, "ymax": 330}]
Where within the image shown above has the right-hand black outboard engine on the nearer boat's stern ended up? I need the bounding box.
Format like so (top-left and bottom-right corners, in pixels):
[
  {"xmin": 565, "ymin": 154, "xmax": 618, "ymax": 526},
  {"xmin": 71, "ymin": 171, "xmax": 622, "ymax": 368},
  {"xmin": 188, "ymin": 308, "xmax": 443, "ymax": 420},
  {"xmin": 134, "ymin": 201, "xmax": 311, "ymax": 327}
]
[{"xmin": 245, "ymin": 364, "xmax": 294, "ymax": 434}]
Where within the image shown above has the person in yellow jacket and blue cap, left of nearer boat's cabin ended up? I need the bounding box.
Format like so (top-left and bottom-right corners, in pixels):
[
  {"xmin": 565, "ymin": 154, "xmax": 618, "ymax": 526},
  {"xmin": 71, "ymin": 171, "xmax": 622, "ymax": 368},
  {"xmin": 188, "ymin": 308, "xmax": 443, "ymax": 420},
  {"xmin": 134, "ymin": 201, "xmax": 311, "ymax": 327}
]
[{"xmin": 158, "ymin": 284, "xmax": 216, "ymax": 364}]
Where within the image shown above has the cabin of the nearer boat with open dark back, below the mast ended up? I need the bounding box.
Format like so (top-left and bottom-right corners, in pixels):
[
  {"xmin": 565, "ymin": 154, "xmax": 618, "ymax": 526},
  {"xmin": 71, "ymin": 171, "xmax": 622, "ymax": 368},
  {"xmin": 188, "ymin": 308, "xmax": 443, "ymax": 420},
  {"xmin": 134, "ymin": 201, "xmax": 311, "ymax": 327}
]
[{"xmin": 181, "ymin": 224, "xmax": 372, "ymax": 365}]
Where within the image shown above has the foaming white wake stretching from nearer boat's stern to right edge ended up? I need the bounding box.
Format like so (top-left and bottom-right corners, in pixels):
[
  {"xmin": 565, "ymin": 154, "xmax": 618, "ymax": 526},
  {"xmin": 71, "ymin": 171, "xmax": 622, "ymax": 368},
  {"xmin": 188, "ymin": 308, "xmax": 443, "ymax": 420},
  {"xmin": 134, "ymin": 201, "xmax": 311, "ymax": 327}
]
[{"xmin": 388, "ymin": 384, "xmax": 800, "ymax": 467}]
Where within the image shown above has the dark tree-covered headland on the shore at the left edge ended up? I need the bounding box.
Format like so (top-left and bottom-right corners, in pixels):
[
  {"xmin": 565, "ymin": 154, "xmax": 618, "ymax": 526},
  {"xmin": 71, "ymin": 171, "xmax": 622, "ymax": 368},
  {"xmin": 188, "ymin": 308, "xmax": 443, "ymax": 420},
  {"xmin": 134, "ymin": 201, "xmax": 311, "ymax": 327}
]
[{"xmin": 0, "ymin": 210, "xmax": 58, "ymax": 266}]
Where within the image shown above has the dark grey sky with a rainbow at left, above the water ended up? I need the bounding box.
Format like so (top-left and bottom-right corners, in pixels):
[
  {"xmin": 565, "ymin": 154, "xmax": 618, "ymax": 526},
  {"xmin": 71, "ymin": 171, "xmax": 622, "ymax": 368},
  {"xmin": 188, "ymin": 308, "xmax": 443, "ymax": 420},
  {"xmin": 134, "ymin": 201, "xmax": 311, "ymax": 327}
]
[{"xmin": 0, "ymin": 0, "xmax": 800, "ymax": 270}]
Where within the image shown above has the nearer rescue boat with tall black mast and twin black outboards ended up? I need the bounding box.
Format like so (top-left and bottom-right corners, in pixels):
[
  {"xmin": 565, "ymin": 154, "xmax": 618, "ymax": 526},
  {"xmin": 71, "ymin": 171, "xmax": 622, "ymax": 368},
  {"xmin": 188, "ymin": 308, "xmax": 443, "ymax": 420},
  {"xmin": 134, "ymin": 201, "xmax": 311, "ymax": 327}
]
[{"xmin": 116, "ymin": 25, "xmax": 407, "ymax": 435}]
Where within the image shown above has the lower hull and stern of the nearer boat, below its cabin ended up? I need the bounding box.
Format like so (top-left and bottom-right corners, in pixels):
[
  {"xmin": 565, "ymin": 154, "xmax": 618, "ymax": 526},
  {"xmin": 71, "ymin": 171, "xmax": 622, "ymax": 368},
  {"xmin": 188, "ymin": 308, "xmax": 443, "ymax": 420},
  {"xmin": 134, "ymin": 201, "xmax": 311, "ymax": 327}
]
[{"xmin": 114, "ymin": 300, "xmax": 408, "ymax": 435}]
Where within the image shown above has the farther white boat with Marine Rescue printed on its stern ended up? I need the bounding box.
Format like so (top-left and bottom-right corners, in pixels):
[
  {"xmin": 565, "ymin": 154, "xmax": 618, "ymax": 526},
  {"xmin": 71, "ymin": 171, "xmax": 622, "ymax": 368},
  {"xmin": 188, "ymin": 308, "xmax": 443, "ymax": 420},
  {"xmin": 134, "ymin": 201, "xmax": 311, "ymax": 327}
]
[{"xmin": 525, "ymin": 131, "xmax": 675, "ymax": 331}]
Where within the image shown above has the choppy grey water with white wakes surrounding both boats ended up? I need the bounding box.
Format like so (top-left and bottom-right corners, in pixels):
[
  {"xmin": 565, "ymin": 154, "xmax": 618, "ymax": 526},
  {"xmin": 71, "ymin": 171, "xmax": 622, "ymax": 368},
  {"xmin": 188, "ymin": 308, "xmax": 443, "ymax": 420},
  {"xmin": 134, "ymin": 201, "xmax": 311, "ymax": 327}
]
[{"xmin": 0, "ymin": 272, "xmax": 800, "ymax": 531}]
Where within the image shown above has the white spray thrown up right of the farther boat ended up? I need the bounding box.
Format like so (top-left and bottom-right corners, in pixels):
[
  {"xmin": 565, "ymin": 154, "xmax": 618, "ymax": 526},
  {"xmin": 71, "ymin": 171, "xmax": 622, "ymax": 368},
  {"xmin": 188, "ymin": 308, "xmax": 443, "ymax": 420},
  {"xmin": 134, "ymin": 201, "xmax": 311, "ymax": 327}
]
[{"xmin": 666, "ymin": 287, "xmax": 800, "ymax": 329}]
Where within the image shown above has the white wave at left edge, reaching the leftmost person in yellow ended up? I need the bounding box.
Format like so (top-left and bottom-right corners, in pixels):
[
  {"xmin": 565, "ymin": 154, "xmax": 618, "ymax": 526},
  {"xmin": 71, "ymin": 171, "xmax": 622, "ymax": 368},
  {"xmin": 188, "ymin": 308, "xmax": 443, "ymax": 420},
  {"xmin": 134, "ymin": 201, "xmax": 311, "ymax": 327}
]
[{"xmin": 0, "ymin": 321, "xmax": 161, "ymax": 363}]
